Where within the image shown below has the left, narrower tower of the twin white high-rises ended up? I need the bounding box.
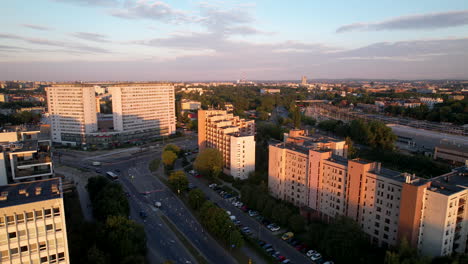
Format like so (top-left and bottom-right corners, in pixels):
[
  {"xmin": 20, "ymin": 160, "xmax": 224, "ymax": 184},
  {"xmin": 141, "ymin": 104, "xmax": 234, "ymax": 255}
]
[{"xmin": 46, "ymin": 84, "xmax": 98, "ymax": 145}]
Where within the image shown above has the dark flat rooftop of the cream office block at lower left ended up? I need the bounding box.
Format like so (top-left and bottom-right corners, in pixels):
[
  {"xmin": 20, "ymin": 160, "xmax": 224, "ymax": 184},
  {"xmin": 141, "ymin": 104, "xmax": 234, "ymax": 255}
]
[{"xmin": 0, "ymin": 178, "xmax": 62, "ymax": 208}]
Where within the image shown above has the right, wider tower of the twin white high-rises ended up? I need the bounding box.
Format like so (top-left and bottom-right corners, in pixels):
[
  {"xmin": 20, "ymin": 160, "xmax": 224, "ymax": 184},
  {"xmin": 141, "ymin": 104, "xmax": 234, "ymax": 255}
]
[{"xmin": 109, "ymin": 84, "xmax": 176, "ymax": 135}]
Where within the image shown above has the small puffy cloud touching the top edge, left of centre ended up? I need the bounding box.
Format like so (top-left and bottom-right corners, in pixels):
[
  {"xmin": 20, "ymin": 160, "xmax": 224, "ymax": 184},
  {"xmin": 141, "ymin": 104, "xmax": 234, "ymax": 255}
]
[{"xmin": 111, "ymin": 0, "xmax": 192, "ymax": 23}]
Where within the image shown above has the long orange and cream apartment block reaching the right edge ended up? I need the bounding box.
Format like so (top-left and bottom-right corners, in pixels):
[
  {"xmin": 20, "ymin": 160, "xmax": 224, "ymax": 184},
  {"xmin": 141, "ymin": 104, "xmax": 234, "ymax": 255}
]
[{"xmin": 268, "ymin": 130, "xmax": 468, "ymax": 256}]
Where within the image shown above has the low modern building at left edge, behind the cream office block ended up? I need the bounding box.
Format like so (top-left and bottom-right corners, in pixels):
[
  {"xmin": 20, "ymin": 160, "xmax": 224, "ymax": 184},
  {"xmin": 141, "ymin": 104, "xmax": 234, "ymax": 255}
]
[{"xmin": 0, "ymin": 129, "xmax": 54, "ymax": 185}]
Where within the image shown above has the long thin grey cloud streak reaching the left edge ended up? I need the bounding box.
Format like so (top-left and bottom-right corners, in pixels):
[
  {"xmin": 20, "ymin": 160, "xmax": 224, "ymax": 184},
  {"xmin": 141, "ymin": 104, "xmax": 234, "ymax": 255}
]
[{"xmin": 0, "ymin": 33, "xmax": 109, "ymax": 53}]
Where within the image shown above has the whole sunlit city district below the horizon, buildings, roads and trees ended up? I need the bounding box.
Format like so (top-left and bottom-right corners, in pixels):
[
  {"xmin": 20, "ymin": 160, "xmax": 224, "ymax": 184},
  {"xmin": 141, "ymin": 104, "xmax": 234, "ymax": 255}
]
[{"xmin": 0, "ymin": 76, "xmax": 468, "ymax": 264}]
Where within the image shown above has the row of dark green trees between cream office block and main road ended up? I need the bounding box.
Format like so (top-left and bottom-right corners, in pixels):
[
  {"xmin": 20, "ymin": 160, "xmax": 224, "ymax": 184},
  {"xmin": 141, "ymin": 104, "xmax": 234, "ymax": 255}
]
[{"xmin": 82, "ymin": 176, "xmax": 146, "ymax": 264}]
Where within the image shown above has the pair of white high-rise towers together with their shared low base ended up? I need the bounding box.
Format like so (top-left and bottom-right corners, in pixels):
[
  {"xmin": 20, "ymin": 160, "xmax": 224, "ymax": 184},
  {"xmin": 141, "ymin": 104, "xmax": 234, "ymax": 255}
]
[{"xmin": 47, "ymin": 83, "xmax": 176, "ymax": 147}]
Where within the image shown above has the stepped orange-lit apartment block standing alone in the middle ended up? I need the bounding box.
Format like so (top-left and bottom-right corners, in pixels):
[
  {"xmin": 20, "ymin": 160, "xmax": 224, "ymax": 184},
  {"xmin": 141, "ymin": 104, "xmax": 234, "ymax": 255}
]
[{"xmin": 198, "ymin": 110, "xmax": 255, "ymax": 179}]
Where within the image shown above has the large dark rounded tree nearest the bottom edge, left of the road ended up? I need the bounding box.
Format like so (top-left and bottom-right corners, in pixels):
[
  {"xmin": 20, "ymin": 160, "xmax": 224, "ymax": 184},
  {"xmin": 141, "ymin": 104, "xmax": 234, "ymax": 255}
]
[{"xmin": 100, "ymin": 216, "xmax": 146, "ymax": 263}]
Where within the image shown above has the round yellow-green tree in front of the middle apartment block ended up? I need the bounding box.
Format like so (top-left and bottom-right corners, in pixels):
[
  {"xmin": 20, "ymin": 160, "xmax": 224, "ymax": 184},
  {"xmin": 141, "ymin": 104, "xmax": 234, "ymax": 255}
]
[{"xmin": 193, "ymin": 148, "xmax": 223, "ymax": 177}]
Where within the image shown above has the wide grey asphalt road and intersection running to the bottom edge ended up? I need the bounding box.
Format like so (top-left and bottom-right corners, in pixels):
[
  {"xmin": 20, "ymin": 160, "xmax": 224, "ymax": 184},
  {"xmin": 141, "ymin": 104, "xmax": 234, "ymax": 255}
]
[{"xmin": 56, "ymin": 139, "xmax": 236, "ymax": 264}]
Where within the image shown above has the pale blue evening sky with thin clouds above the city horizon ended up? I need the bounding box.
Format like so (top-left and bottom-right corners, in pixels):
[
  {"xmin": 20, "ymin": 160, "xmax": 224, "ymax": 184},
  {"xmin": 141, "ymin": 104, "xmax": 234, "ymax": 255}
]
[{"xmin": 0, "ymin": 0, "xmax": 468, "ymax": 81}]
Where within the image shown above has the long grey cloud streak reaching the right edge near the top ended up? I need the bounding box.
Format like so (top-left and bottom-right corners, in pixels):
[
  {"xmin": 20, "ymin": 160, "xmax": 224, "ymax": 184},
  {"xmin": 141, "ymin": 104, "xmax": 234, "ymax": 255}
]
[{"xmin": 336, "ymin": 10, "xmax": 468, "ymax": 33}]
